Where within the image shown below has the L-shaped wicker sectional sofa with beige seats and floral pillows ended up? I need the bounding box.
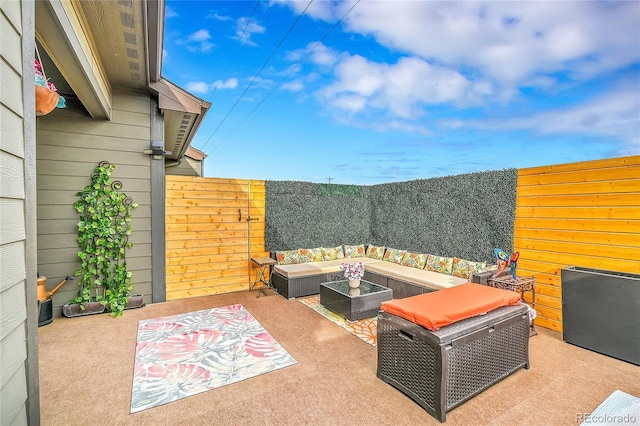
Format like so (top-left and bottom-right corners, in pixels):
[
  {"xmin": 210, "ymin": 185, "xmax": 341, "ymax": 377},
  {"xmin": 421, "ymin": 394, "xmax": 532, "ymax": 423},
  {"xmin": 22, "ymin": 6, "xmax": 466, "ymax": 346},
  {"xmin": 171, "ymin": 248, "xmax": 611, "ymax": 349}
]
[{"xmin": 271, "ymin": 244, "xmax": 492, "ymax": 299}]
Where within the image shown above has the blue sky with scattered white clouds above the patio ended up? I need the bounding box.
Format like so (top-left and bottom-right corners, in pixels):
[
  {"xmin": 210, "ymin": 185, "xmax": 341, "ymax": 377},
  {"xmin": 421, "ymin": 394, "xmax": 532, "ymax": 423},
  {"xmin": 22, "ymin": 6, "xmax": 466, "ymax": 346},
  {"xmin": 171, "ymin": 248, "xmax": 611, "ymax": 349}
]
[{"xmin": 163, "ymin": 0, "xmax": 640, "ymax": 184}]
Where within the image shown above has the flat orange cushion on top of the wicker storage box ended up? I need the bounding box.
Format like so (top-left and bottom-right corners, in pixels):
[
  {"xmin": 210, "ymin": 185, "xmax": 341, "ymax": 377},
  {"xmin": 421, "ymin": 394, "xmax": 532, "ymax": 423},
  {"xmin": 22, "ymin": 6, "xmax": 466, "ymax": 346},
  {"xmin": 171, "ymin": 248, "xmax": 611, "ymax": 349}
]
[{"xmin": 380, "ymin": 283, "xmax": 521, "ymax": 331}]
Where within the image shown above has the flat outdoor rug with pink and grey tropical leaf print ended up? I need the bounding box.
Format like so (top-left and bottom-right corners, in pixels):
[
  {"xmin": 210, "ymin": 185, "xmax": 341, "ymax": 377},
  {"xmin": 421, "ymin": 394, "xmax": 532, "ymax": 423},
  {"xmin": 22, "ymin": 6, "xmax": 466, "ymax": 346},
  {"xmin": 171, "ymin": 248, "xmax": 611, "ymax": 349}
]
[{"xmin": 131, "ymin": 304, "xmax": 296, "ymax": 413}]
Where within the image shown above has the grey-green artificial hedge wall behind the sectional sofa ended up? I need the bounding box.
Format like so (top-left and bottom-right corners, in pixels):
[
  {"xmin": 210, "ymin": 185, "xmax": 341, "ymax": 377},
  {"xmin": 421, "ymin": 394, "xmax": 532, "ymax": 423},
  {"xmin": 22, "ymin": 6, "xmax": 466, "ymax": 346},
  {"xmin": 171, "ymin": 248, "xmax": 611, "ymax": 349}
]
[{"xmin": 265, "ymin": 169, "xmax": 518, "ymax": 261}]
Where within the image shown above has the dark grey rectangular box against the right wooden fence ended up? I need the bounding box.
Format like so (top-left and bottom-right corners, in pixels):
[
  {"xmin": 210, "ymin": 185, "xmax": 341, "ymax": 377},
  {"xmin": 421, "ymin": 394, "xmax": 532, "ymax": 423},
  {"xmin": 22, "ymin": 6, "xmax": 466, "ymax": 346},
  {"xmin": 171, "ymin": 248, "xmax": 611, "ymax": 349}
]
[{"xmin": 562, "ymin": 266, "xmax": 640, "ymax": 365}]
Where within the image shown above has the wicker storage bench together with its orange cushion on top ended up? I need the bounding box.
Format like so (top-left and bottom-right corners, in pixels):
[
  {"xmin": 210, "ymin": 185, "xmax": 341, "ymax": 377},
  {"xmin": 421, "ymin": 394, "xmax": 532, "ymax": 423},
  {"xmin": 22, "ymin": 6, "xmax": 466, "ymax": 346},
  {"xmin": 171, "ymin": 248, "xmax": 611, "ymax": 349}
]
[{"xmin": 377, "ymin": 283, "xmax": 529, "ymax": 422}]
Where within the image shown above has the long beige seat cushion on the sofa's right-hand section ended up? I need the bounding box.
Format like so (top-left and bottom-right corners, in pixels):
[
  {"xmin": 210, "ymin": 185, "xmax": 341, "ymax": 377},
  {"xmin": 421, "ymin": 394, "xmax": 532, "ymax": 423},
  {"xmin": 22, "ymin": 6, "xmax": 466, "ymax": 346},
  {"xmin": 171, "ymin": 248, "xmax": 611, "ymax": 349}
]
[{"xmin": 364, "ymin": 262, "xmax": 469, "ymax": 290}]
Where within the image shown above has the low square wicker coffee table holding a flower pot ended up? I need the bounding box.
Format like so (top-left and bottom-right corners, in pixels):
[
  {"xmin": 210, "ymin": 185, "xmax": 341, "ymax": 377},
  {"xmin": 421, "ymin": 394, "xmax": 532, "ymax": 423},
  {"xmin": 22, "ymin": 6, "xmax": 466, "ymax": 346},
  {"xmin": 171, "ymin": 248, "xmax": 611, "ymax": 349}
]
[{"xmin": 320, "ymin": 280, "xmax": 393, "ymax": 321}]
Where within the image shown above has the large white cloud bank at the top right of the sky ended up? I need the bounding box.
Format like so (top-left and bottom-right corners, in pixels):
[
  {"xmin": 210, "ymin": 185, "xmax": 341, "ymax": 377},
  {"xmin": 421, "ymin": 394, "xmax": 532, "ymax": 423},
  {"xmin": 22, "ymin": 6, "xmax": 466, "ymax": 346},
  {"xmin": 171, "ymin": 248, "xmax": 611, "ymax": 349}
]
[{"xmin": 346, "ymin": 1, "xmax": 640, "ymax": 85}]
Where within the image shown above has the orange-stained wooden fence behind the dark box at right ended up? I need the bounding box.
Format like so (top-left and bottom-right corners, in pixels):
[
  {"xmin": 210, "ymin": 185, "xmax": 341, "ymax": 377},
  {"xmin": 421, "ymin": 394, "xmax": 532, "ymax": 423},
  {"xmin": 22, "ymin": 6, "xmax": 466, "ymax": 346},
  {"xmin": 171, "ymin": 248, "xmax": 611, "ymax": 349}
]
[{"xmin": 514, "ymin": 156, "xmax": 640, "ymax": 331}]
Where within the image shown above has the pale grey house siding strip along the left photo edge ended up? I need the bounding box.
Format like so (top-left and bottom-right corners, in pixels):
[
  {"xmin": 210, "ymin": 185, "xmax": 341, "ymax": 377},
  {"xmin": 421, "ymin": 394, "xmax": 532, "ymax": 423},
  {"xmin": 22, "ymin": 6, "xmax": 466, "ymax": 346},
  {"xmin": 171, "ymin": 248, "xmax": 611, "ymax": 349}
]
[{"xmin": 0, "ymin": 2, "xmax": 39, "ymax": 425}]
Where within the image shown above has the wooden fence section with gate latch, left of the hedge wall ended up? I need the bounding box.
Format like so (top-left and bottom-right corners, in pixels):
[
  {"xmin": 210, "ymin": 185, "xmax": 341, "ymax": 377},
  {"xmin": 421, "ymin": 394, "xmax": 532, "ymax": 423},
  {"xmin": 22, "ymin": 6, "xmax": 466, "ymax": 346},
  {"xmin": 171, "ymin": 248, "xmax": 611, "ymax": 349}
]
[{"xmin": 166, "ymin": 176, "xmax": 268, "ymax": 300}]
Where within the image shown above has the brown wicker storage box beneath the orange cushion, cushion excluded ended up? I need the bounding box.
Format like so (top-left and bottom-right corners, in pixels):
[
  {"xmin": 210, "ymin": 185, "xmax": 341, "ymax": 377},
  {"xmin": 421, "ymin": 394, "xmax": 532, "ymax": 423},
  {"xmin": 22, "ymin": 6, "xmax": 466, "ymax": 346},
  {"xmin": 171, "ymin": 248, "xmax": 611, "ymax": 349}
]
[{"xmin": 377, "ymin": 304, "xmax": 529, "ymax": 422}]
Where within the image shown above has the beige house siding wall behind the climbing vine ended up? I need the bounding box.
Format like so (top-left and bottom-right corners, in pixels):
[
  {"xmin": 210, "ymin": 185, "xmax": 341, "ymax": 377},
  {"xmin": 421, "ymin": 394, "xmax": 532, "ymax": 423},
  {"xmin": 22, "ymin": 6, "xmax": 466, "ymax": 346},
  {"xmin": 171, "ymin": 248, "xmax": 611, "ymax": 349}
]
[{"xmin": 37, "ymin": 92, "xmax": 152, "ymax": 316}]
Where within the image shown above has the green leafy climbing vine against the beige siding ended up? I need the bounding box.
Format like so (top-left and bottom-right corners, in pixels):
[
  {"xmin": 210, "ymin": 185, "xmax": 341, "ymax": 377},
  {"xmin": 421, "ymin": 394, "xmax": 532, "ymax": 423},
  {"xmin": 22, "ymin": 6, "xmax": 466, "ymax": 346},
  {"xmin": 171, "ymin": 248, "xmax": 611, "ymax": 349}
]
[{"xmin": 71, "ymin": 161, "xmax": 138, "ymax": 318}]
